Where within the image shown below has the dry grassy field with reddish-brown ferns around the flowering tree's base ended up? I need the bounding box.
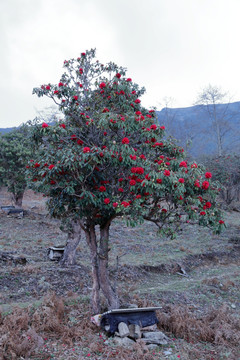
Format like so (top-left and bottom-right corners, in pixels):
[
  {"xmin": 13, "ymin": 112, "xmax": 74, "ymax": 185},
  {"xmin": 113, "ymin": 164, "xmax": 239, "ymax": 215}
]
[{"xmin": 0, "ymin": 190, "xmax": 240, "ymax": 360}]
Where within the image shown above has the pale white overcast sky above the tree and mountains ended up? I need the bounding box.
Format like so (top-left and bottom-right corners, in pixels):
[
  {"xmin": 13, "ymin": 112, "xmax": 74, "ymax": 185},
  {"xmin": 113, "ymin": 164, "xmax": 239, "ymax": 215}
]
[{"xmin": 0, "ymin": 0, "xmax": 240, "ymax": 127}]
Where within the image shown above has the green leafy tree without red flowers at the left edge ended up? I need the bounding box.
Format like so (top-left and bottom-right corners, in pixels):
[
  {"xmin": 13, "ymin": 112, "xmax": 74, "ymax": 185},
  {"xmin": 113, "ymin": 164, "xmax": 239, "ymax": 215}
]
[{"xmin": 0, "ymin": 125, "xmax": 31, "ymax": 207}]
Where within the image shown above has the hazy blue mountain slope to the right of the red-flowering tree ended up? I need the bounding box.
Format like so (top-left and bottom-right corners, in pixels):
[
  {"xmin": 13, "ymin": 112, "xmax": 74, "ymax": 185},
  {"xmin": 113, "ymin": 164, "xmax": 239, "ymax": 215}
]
[{"xmin": 157, "ymin": 101, "xmax": 240, "ymax": 157}]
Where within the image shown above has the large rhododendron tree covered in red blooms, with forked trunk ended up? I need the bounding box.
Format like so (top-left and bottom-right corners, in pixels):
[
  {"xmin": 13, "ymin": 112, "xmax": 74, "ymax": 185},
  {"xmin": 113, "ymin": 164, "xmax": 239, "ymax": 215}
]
[{"xmin": 29, "ymin": 50, "xmax": 224, "ymax": 313}]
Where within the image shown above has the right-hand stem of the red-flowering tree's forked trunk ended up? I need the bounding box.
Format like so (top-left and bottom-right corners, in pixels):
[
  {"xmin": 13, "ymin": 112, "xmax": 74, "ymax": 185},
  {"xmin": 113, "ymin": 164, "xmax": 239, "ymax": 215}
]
[{"xmin": 98, "ymin": 223, "xmax": 119, "ymax": 309}]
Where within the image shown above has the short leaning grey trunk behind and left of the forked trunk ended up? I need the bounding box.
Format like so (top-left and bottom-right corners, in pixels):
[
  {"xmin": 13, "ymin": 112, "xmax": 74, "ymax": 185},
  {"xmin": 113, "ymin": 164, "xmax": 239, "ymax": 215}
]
[{"xmin": 60, "ymin": 221, "xmax": 81, "ymax": 266}]
